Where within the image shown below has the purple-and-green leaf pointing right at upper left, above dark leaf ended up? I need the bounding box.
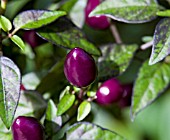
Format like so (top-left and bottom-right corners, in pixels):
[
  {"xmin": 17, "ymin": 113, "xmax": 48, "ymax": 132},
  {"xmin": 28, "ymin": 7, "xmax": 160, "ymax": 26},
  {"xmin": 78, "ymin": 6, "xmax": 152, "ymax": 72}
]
[{"xmin": 13, "ymin": 10, "xmax": 66, "ymax": 29}]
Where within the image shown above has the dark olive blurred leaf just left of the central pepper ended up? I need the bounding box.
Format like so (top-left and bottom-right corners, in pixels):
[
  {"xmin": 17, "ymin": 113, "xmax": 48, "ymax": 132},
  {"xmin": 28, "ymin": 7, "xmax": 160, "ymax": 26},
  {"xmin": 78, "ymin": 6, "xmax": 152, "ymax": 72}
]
[{"xmin": 36, "ymin": 60, "xmax": 67, "ymax": 96}]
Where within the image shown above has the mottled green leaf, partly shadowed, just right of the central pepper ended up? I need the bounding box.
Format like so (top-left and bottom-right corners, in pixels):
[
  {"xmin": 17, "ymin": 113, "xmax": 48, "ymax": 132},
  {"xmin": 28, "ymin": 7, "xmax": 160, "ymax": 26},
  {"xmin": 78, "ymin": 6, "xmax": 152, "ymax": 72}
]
[{"xmin": 98, "ymin": 44, "xmax": 138, "ymax": 80}]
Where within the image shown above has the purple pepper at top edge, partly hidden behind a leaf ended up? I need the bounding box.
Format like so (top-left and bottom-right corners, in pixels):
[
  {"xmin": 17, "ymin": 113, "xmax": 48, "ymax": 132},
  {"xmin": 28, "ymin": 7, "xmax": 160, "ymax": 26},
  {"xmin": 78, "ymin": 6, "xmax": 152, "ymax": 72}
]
[{"xmin": 85, "ymin": 0, "xmax": 110, "ymax": 29}]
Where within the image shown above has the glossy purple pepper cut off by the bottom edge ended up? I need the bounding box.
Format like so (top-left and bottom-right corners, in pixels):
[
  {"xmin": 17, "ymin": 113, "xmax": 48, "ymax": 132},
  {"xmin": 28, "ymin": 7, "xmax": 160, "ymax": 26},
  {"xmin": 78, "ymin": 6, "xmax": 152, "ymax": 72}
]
[{"xmin": 12, "ymin": 116, "xmax": 45, "ymax": 140}]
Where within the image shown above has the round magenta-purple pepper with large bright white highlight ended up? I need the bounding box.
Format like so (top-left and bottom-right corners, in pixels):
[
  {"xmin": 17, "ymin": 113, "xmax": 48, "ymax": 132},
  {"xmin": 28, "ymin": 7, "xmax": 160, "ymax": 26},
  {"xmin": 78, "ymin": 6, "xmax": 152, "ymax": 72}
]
[{"xmin": 96, "ymin": 78, "xmax": 123, "ymax": 105}]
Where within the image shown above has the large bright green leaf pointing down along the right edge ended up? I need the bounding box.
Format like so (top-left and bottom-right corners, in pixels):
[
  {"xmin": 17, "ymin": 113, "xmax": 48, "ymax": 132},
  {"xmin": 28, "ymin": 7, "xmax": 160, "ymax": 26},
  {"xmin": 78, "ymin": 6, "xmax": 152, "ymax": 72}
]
[{"xmin": 131, "ymin": 61, "xmax": 170, "ymax": 120}]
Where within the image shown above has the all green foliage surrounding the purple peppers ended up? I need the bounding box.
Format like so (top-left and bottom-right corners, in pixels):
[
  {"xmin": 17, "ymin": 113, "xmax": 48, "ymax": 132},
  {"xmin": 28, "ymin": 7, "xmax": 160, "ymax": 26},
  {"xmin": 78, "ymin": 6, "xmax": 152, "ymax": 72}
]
[{"xmin": 0, "ymin": 0, "xmax": 170, "ymax": 140}]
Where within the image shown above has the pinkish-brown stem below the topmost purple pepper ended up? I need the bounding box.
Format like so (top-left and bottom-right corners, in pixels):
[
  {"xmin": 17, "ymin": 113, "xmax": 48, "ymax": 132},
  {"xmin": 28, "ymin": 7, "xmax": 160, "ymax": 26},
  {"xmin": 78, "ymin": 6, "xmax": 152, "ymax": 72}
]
[{"xmin": 110, "ymin": 23, "xmax": 122, "ymax": 44}]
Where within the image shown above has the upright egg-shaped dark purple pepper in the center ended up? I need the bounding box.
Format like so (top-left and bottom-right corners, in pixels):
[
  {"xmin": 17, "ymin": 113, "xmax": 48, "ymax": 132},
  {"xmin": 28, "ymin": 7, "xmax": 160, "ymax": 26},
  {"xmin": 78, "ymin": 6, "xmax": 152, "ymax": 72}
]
[{"xmin": 64, "ymin": 47, "xmax": 97, "ymax": 87}]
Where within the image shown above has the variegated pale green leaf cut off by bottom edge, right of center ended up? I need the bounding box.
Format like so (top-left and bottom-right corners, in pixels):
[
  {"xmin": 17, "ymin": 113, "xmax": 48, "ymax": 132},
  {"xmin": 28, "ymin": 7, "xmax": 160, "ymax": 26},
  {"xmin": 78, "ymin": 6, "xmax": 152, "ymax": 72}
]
[{"xmin": 66, "ymin": 122, "xmax": 126, "ymax": 140}]
